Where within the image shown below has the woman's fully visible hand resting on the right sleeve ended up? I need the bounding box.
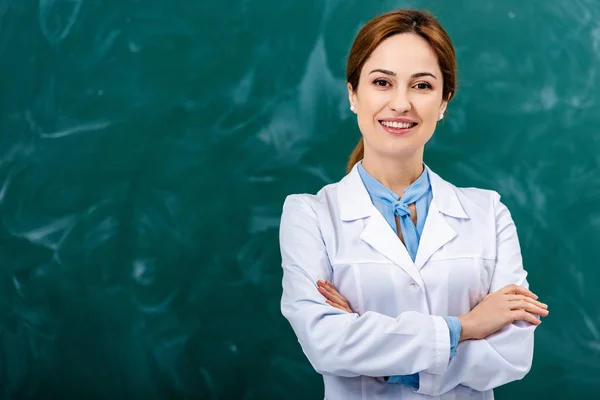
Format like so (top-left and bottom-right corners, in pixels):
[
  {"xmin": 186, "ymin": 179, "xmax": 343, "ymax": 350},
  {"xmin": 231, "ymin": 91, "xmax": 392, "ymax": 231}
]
[{"xmin": 458, "ymin": 285, "xmax": 548, "ymax": 341}]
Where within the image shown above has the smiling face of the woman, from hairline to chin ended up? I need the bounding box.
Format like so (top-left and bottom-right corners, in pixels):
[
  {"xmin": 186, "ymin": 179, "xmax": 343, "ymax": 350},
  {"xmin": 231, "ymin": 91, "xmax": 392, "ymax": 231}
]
[{"xmin": 348, "ymin": 33, "xmax": 447, "ymax": 159}]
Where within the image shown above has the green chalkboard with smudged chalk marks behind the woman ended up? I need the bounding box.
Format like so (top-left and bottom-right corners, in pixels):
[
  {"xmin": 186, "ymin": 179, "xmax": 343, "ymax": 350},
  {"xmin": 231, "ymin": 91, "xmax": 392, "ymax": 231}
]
[{"xmin": 0, "ymin": 0, "xmax": 600, "ymax": 399}]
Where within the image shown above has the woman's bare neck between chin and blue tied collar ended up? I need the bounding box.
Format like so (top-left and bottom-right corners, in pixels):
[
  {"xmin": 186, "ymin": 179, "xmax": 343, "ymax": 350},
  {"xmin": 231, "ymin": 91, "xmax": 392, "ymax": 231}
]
[{"xmin": 362, "ymin": 149, "xmax": 424, "ymax": 196}]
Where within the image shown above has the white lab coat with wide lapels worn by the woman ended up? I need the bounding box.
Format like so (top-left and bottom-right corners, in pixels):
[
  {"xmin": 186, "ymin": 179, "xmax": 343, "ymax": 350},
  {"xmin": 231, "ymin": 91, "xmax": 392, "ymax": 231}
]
[{"xmin": 280, "ymin": 166, "xmax": 535, "ymax": 400}]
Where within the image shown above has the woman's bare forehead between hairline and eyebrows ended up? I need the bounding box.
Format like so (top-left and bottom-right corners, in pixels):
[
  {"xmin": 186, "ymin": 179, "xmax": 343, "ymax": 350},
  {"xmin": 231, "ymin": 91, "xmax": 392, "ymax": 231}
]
[{"xmin": 361, "ymin": 33, "xmax": 441, "ymax": 78}]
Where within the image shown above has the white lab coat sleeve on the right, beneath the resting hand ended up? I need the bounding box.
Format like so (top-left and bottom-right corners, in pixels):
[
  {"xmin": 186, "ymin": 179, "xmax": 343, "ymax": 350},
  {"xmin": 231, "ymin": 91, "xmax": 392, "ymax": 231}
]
[{"xmin": 415, "ymin": 194, "xmax": 536, "ymax": 396}]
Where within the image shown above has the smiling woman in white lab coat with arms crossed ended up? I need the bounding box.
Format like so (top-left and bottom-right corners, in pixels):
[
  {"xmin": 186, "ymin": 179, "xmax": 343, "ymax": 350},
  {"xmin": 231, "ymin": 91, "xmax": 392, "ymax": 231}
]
[{"xmin": 280, "ymin": 10, "xmax": 548, "ymax": 400}]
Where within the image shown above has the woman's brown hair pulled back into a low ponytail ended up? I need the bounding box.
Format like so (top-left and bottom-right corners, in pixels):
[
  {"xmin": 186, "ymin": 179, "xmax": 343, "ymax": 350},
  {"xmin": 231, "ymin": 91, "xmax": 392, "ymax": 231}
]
[{"xmin": 346, "ymin": 10, "xmax": 456, "ymax": 172}]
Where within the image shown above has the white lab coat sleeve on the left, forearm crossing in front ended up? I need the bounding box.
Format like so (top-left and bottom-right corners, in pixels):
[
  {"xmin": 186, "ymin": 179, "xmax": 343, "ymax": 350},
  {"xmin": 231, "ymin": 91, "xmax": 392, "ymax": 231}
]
[{"xmin": 280, "ymin": 195, "xmax": 450, "ymax": 377}]
